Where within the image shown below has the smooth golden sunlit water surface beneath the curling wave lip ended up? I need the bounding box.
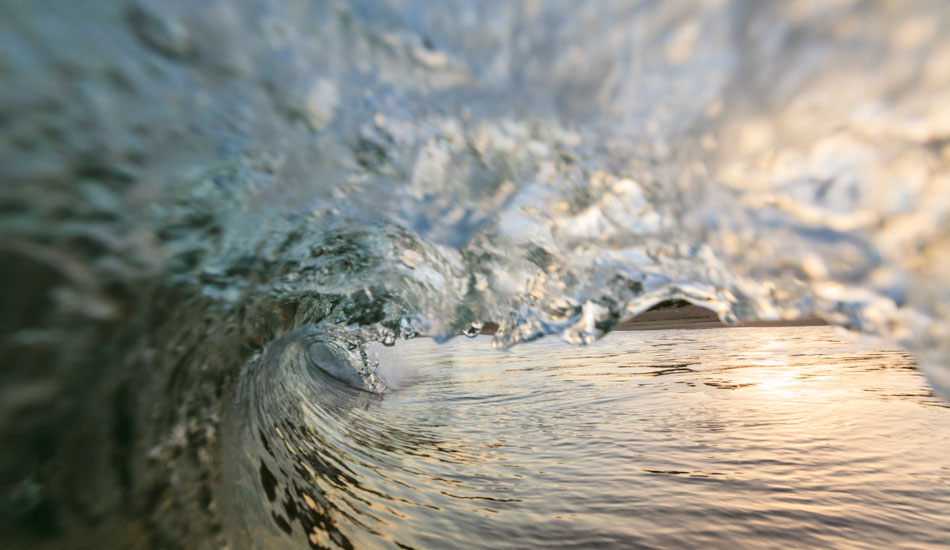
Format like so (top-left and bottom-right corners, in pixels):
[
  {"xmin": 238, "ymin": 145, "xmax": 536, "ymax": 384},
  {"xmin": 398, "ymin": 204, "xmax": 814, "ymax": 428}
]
[{"xmin": 223, "ymin": 327, "xmax": 950, "ymax": 548}]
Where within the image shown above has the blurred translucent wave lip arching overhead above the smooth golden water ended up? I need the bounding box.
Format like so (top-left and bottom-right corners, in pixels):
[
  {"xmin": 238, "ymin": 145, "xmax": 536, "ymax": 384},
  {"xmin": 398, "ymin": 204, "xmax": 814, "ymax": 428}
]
[{"xmin": 0, "ymin": 0, "xmax": 950, "ymax": 548}]
